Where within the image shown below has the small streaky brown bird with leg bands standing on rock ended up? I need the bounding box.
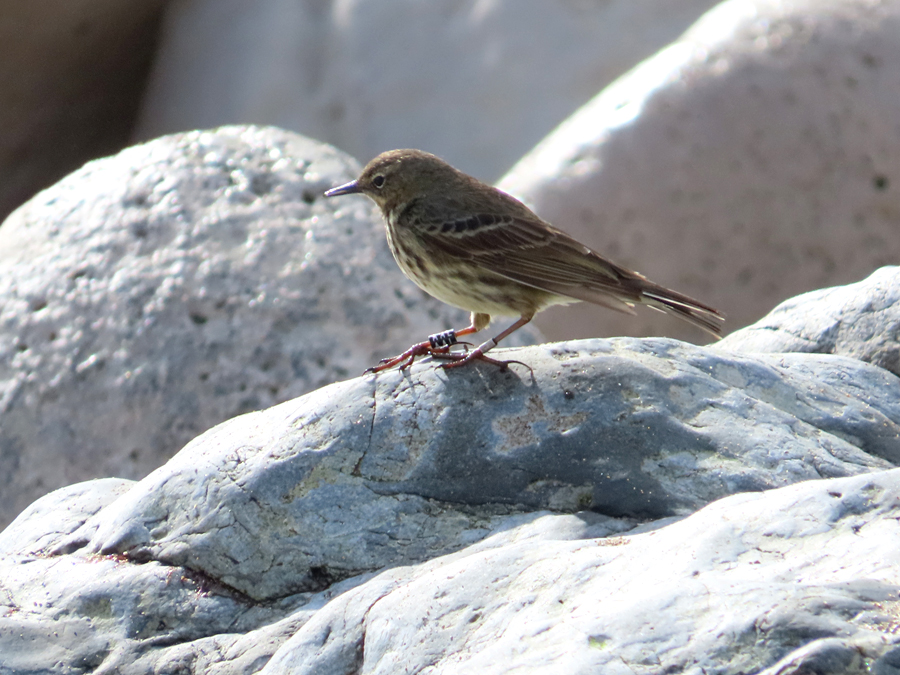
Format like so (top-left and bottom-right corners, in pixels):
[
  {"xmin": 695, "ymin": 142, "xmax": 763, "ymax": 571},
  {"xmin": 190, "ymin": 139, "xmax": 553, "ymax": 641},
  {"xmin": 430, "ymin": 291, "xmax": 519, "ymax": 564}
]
[{"xmin": 325, "ymin": 150, "xmax": 724, "ymax": 372}]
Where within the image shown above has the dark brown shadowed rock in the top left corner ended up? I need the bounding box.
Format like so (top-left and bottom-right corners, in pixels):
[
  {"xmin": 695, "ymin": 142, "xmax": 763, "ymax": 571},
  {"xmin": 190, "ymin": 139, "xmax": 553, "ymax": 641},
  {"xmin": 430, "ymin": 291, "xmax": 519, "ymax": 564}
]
[{"xmin": 0, "ymin": 0, "xmax": 168, "ymax": 221}]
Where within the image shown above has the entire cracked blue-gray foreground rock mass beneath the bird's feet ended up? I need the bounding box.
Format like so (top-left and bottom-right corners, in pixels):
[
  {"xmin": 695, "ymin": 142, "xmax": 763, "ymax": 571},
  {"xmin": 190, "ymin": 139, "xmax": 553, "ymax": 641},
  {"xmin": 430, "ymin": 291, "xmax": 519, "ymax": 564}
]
[{"xmin": 0, "ymin": 262, "xmax": 900, "ymax": 675}]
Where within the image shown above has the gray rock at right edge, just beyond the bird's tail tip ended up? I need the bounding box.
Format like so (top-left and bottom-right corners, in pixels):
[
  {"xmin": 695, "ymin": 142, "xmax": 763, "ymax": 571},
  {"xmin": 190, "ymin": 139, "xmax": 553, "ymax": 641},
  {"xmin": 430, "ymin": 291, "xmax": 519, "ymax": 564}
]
[{"xmin": 714, "ymin": 267, "xmax": 900, "ymax": 375}]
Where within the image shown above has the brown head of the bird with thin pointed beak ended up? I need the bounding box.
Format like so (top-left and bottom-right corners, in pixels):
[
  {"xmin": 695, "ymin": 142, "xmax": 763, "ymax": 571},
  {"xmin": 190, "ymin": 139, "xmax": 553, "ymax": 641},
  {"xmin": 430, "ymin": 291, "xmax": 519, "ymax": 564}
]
[{"xmin": 325, "ymin": 150, "xmax": 462, "ymax": 213}]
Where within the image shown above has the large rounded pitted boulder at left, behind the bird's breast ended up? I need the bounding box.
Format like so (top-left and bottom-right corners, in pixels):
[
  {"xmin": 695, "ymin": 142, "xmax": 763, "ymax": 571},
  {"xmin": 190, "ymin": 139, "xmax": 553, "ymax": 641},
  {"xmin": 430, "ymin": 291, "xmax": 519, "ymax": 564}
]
[{"xmin": 0, "ymin": 127, "xmax": 535, "ymax": 524}]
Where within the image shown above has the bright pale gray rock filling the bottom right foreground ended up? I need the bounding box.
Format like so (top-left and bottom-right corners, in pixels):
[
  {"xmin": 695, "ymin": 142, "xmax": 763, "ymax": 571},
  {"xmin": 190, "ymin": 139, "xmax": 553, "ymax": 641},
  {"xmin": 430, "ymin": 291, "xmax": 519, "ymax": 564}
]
[{"xmin": 261, "ymin": 471, "xmax": 900, "ymax": 675}]
